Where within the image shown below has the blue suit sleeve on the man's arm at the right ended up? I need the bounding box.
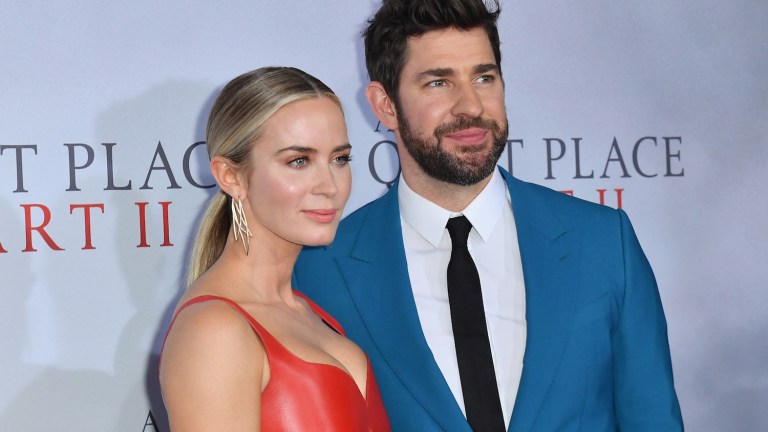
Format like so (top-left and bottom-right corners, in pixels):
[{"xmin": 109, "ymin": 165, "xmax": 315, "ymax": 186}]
[{"xmin": 613, "ymin": 210, "xmax": 683, "ymax": 432}]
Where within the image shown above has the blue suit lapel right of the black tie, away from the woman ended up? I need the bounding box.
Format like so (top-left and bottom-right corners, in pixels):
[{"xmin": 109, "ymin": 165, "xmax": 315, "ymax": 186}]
[{"xmin": 502, "ymin": 170, "xmax": 579, "ymax": 431}]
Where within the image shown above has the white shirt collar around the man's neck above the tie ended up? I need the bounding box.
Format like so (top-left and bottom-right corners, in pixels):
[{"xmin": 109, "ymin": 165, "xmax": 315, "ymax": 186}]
[{"xmin": 397, "ymin": 170, "xmax": 509, "ymax": 247}]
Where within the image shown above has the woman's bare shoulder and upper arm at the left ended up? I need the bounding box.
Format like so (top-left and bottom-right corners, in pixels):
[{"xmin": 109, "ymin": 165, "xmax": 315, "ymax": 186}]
[{"xmin": 160, "ymin": 300, "xmax": 268, "ymax": 431}]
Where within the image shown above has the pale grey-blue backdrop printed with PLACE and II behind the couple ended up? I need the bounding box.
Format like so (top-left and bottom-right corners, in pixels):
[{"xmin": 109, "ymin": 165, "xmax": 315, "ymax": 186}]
[{"xmin": 0, "ymin": 0, "xmax": 768, "ymax": 431}]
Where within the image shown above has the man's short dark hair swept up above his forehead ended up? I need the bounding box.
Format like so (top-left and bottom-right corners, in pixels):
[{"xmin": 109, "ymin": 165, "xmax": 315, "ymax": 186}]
[{"xmin": 363, "ymin": 0, "xmax": 501, "ymax": 103}]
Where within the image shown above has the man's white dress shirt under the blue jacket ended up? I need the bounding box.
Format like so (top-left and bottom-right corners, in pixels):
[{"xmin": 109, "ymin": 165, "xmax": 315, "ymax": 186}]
[{"xmin": 398, "ymin": 170, "xmax": 526, "ymax": 425}]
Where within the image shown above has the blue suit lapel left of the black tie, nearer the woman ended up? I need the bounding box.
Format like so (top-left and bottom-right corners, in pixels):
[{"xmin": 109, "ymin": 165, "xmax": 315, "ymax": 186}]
[{"xmin": 337, "ymin": 184, "xmax": 469, "ymax": 430}]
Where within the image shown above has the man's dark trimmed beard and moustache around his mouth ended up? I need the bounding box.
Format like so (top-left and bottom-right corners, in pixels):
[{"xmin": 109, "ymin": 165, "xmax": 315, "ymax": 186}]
[{"xmin": 397, "ymin": 109, "xmax": 509, "ymax": 186}]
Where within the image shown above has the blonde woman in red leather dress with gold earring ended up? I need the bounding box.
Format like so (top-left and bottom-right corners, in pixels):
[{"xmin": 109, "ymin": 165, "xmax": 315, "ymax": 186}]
[{"xmin": 160, "ymin": 67, "xmax": 389, "ymax": 432}]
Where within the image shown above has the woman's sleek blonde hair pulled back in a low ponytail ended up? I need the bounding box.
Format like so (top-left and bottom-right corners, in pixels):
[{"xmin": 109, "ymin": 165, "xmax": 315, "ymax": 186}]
[{"xmin": 187, "ymin": 66, "xmax": 341, "ymax": 285}]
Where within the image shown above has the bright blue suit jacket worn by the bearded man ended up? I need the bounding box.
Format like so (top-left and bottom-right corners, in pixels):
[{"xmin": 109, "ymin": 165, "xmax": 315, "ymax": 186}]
[{"xmin": 294, "ymin": 168, "xmax": 682, "ymax": 432}]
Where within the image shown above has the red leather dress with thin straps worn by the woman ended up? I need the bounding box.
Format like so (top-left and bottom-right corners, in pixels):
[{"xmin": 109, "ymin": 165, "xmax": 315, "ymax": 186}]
[{"xmin": 163, "ymin": 292, "xmax": 390, "ymax": 432}]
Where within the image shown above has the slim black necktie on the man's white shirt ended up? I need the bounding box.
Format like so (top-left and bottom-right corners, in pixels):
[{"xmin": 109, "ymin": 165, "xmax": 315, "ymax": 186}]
[{"xmin": 447, "ymin": 216, "xmax": 505, "ymax": 432}]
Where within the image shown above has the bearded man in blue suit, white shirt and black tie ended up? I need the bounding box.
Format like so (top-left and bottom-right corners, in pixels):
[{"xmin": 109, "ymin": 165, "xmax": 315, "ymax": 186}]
[{"xmin": 294, "ymin": 0, "xmax": 682, "ymax": 431}]
